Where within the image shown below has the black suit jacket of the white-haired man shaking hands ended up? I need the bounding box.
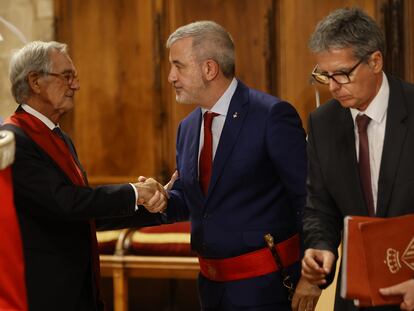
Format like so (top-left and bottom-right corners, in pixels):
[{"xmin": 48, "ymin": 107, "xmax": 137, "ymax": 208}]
[{"xmin": 3, "ymin": 125, "xmax": 157, "ymax": 311}]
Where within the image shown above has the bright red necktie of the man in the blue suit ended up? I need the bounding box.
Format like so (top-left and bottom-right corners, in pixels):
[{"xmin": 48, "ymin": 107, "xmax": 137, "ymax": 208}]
[{"xmin": 199, "ymin": 111, "xmax": 219, "ymax": 195}]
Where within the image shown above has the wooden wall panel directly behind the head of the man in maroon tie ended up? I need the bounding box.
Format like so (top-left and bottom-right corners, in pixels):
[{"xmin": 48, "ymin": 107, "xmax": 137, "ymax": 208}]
[{"xmin": 276, "ymin": 0, "xmax": 377, "ymax": 126}]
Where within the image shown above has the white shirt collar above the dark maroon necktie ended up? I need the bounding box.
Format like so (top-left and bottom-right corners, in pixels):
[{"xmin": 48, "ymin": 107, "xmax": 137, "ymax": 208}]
[{"xmin": 351, "ymin": 72, "xmax": 390, "ymax": 123}]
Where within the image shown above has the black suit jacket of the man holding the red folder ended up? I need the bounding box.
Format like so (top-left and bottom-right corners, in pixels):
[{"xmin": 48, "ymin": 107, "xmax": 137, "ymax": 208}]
[{"xmin": 303, "ymin": 77, "xmax": 414, "ymax": 310}]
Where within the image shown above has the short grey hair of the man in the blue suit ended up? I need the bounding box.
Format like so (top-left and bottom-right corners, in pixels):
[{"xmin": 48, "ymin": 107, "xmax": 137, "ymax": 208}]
[{"xmin": 166, "ymin": 21, "xmax": 235, "ymax": 78}]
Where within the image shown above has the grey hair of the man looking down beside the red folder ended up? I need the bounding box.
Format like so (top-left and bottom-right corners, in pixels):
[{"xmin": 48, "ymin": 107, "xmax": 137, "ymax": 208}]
[{"xmin": 309, "ymin": 8, "xmax": 385, "ymax": 59}]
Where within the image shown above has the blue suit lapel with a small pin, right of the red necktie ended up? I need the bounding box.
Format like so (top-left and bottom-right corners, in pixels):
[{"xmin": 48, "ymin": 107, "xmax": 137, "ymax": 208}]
[{"xmin": 206, "ymin": 81, "xmax": 249, "ymax": 199}]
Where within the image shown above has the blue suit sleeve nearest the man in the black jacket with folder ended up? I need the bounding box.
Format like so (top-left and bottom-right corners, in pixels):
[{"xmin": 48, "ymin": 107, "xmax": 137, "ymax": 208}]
[{"xmin": 266, "ymin": 102, "xmax": 307, "ymax": 231}]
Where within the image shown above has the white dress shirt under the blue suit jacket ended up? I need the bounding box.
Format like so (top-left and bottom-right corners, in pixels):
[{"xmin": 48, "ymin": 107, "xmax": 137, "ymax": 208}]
[{"xmin": 198, "ymin": 78, "xmax": 238, "ymax": 176}]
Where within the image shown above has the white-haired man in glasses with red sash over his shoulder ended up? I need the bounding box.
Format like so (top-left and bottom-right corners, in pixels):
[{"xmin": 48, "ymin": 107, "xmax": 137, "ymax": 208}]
[{"xmin": 0, "ymin": 41, "xmax": 166, "ymax": 311}]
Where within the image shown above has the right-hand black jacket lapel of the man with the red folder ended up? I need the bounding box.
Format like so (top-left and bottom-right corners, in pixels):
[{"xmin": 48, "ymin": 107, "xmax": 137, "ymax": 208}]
[{"xmin": 377, "ymin": 77, "xmax": 407, "ymax": 217}]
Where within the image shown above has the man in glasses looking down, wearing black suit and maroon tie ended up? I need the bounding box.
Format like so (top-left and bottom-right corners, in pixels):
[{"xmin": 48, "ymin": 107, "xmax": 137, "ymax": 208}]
[{"xmin": 296, "ymin": 8, "xmax": 414, "ymax": 311}]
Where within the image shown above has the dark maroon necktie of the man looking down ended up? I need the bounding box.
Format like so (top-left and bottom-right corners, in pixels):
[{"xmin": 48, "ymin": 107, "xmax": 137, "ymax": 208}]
[{"xmin": 356, "ymin": 114, "xmax": 375, "ymax": 216}]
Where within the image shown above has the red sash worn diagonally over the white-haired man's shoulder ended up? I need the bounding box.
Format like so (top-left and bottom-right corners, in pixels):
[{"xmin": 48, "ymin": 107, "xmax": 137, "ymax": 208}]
[{"xmin": 5, "ymin": 111, "xmax": 100, "ymax": 304}]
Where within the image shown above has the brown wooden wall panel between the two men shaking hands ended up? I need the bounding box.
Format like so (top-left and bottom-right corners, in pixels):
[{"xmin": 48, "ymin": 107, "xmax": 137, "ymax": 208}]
[{"xmin": 56, "ymin": 0, "xmax": 161, "ymax": 184}]
